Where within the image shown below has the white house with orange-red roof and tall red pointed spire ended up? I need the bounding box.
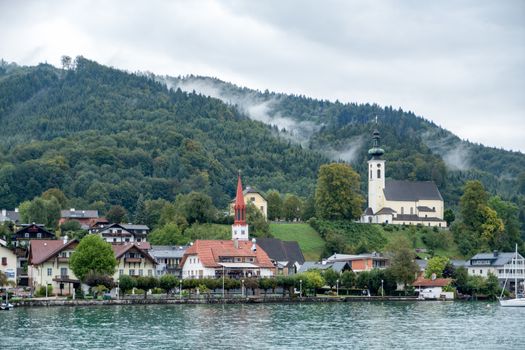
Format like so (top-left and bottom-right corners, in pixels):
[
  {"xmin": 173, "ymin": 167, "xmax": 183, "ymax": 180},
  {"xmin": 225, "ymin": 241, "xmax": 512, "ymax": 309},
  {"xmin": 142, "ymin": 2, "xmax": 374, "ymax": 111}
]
[{"xmin": 181, "ymin": 176, "xmax": 275, "ymax": 278}]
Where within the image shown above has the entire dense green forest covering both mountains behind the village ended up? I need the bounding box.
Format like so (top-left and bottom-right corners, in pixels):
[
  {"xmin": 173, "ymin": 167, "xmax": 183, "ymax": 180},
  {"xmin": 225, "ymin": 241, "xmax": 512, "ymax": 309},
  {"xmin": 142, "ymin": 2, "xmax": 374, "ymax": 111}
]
[{"xmin": 0, "ymin": 57, "xmax": 525, "ymax": 230}]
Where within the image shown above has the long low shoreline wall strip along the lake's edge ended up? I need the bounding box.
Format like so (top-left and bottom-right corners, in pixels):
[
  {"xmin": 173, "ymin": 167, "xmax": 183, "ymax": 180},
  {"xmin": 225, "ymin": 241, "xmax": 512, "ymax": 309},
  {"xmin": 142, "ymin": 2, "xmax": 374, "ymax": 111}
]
[{"xmin": 12, "ymin": 296, "xmax": 454, "ymax": 308}]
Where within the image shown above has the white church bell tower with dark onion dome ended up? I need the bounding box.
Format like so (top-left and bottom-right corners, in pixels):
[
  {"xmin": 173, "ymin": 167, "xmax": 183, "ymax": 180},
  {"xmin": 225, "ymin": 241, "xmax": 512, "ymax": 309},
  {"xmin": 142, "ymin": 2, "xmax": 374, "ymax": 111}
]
[{"xmin": 368, "ymin": 129, "xmax": 386, "ymax": 214}]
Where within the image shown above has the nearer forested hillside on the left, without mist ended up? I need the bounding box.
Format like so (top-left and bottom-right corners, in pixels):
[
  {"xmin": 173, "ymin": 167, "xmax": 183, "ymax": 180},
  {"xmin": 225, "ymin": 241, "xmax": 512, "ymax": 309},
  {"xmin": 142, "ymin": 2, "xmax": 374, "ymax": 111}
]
[{"xmin": 0, "ymin": 58, "xmax": 327, "ymax": 211}]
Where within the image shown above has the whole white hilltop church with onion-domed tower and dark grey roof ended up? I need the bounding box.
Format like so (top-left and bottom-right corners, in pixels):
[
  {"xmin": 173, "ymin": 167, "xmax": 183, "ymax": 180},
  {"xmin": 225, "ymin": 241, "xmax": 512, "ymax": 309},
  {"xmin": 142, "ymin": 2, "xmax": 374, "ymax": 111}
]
[{"xmin": 361, "ymin": 130, "xmax": 447, "ymax": 227}]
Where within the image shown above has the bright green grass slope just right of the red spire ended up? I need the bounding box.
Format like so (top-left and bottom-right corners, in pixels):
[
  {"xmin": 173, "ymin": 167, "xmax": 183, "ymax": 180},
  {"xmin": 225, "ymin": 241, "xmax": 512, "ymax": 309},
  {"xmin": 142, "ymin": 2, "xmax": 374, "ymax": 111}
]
[{"xmin": 270, "ymin": 224, "xmax": 324, "ymax": 261}]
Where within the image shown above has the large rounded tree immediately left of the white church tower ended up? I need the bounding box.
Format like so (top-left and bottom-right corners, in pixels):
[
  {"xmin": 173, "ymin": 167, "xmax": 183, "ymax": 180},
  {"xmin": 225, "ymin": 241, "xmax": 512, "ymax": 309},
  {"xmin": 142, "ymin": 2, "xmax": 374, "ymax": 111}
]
[{"xmin": 315, "ymin": 163, "xmax": 364, "ymax": 220}]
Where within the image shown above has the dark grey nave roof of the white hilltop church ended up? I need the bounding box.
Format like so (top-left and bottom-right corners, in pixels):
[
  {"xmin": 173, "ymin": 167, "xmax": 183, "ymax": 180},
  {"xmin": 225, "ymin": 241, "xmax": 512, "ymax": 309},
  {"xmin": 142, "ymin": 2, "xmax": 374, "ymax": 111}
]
[{"xmin": 383, "ymin": 179, "xmax": 443, "ymax": 202}]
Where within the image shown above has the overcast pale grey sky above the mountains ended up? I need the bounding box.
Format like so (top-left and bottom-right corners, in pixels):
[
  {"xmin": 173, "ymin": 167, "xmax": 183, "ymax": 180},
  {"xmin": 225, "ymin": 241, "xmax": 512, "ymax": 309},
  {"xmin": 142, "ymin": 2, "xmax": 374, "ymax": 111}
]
[{"xmin": 0, "ymin": 0, "xmax": 525, "ymax": 152}]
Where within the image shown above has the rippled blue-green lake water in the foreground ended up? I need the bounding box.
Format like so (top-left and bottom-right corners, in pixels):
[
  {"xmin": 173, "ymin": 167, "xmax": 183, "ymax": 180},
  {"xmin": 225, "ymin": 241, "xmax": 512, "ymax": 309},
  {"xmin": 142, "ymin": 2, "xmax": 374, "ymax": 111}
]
[{"xmin": 0, "ymin": 302, "xmax": 525, "ymax": 350}]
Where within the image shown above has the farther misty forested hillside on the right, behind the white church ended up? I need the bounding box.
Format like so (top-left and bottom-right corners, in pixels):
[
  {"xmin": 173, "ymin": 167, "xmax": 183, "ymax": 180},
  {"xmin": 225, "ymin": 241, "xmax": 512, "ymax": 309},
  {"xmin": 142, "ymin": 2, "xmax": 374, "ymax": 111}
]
[{"xmin": 168, "ymin": 76, "xmax": 525, "ymax": 206}]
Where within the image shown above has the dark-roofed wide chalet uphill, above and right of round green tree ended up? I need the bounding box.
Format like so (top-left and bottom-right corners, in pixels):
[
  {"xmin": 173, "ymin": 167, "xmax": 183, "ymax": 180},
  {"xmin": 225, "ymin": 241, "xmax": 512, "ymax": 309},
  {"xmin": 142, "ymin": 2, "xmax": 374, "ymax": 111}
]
[{"xmin": 88, "ymin": 223, "xmax": 150, "ymax": 244}]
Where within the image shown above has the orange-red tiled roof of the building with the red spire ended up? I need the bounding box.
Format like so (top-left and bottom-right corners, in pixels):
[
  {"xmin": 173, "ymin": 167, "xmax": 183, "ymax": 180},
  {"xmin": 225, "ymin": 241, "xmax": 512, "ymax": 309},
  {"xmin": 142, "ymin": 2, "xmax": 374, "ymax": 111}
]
[{"xmin": 181, "ymin": 240, "xmax": 274, "ymax": 268}]
